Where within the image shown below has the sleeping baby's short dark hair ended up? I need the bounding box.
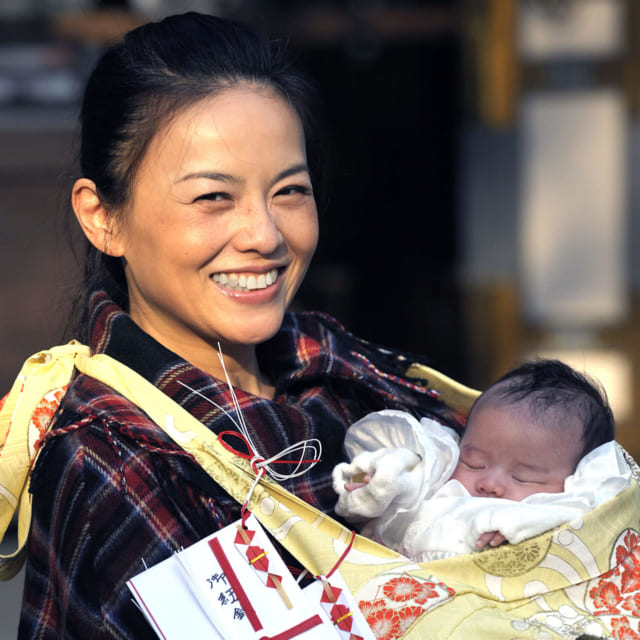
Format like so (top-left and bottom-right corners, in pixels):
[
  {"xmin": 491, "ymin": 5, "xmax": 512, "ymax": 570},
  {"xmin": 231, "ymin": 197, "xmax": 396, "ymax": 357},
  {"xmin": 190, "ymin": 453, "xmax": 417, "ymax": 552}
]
[{"xmin": 476, "ymin": 359, "xmax": 615, "ymax": 458}]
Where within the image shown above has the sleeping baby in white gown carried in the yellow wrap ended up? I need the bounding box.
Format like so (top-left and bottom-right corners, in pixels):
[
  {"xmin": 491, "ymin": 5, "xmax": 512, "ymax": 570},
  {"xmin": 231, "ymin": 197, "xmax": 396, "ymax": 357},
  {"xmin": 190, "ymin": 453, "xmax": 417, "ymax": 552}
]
[{"xmin": 334, "ymin": 360, "xmax": 630, "ymax": 560}]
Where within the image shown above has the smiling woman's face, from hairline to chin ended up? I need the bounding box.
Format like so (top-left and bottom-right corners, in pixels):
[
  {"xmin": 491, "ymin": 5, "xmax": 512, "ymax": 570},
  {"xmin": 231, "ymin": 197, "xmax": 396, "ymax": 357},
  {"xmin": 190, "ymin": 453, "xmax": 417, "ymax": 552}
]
[{"xmin": 116, "ymin": 85, "xmax": 318, "ymax": 361}]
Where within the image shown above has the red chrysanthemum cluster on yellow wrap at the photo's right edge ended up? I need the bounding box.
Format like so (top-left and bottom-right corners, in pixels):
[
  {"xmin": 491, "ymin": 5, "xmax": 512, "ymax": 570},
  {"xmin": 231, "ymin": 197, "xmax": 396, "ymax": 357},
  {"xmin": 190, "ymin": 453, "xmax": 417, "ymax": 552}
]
[{"xmin": 587, "ymin": 529, "xmax": 640, "ymax": 640}]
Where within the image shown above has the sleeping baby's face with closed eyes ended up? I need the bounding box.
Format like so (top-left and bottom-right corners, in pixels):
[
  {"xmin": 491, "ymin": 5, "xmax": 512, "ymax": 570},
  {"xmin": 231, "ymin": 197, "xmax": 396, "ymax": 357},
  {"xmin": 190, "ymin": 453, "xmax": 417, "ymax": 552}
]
[{"xmin": 452, "ymin": 403, "xmax": 582, "ymax": 500}]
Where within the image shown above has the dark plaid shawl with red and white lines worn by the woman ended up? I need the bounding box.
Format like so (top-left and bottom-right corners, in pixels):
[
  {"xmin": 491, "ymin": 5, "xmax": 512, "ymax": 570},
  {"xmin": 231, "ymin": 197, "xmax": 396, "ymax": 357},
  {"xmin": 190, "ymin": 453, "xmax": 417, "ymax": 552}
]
[{"xmin": 19, "ymin": 294, "xmax": 462, "ymax": 640}]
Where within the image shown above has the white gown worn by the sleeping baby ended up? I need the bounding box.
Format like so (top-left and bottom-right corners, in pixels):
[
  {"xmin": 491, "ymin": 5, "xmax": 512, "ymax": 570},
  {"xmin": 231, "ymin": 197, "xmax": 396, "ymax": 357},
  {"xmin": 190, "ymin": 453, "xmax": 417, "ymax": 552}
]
[{"xmin": 333, "ymin": 410, "xmax": 631, "ymax": 561}]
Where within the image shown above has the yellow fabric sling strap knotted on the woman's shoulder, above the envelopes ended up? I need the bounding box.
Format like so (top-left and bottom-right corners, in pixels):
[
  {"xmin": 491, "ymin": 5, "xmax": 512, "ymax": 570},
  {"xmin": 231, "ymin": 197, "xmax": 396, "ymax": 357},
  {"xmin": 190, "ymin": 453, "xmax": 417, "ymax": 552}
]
[{"xmin": 0, "ymin": 343, "xmax": 470, "ymax": 579}]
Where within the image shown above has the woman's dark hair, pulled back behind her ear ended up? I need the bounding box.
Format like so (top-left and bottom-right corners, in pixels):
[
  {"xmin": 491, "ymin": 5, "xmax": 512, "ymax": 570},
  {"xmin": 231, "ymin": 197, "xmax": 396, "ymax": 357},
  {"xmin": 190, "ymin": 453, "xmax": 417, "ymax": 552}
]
[{"xmin": 72, "ymin": 12, "xmax": 322, "ymax": 341}]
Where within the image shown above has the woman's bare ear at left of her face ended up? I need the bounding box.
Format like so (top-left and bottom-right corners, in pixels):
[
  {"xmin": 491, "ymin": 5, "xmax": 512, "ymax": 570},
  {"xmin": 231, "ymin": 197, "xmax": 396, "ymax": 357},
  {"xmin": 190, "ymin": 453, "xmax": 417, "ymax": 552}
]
[{"xmin": 71, "ymin": 178, "xmax": 124, "ymax": 258}]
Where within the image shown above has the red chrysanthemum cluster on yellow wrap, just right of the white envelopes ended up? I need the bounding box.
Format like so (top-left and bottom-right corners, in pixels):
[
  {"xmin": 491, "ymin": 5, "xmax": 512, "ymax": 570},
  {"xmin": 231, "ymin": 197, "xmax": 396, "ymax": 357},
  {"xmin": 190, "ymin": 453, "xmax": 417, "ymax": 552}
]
[{"xmin": 358, "ymin": 573, "xmax": 455, "ymax": 640}]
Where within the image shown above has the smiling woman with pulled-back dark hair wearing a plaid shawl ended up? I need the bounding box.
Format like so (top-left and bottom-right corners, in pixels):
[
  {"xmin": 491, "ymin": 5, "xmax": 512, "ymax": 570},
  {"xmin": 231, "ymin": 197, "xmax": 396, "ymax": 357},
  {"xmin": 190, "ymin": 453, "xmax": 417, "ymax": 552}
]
[{"xmin": 3, "ymin": 13, "xmax": 463, "ymax": 639}]
